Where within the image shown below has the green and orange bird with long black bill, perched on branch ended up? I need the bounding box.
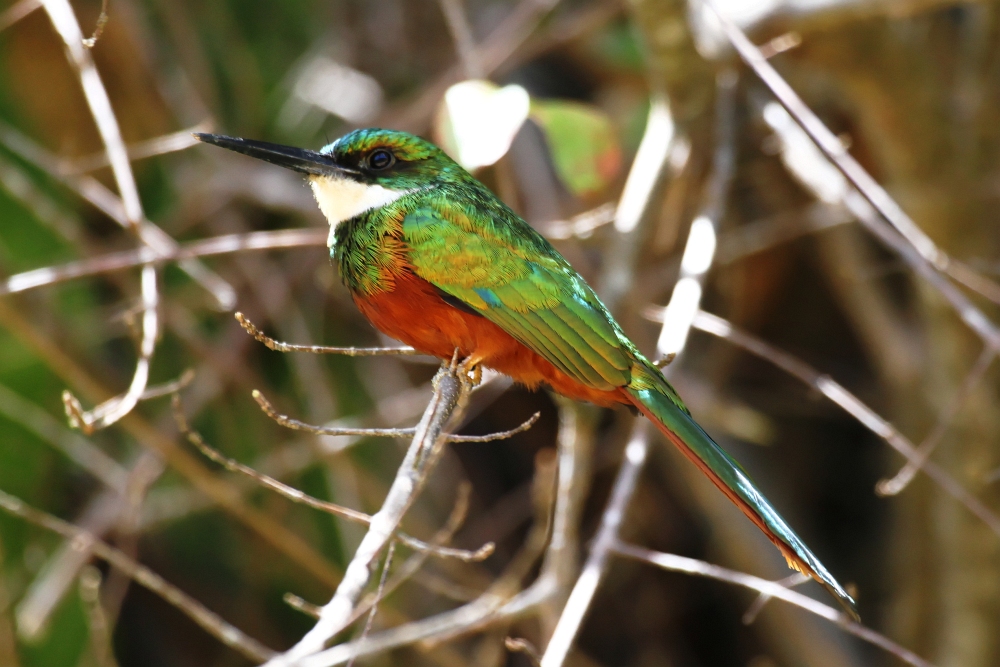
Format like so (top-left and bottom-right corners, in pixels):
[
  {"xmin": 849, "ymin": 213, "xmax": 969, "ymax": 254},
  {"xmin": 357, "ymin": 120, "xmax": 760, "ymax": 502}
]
[{"xmin": 195, "ymin": 128, "xmax": 858, "ymax": 619}]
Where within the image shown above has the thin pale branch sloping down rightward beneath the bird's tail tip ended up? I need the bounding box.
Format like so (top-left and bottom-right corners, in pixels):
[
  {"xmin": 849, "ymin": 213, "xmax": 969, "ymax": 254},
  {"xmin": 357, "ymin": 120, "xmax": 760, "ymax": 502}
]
[{"xmin": 613, "ymin": 542, "xmax": 933, "ymax": 667}]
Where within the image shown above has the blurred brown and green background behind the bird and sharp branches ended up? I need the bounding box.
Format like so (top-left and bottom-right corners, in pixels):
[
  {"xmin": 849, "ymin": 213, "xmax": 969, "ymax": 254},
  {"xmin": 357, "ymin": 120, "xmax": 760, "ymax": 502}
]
[{"xmin": 0, "ymin": 0, "xmax": 1000, "ymax": 667}]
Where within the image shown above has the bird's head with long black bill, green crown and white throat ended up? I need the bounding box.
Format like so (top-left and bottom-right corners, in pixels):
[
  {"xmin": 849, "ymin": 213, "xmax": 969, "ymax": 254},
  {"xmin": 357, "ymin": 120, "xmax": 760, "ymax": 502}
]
[{"xmin": 195, "ymin": 129, "xmax": 467, "ymax": 239}]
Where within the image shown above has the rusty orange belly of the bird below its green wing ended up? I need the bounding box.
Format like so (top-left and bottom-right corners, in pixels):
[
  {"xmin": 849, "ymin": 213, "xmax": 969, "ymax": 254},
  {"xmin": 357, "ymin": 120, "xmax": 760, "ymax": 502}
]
[{"xmin": 354, "ymin": 273, "xmax": 628, "ymax": 405}]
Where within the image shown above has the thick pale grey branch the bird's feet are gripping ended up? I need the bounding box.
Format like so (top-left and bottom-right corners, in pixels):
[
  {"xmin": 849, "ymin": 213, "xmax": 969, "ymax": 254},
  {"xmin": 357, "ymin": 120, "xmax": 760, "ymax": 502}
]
[{"xmin": 268, "ymin": 359, "xmax": 470, "ymax": 667}]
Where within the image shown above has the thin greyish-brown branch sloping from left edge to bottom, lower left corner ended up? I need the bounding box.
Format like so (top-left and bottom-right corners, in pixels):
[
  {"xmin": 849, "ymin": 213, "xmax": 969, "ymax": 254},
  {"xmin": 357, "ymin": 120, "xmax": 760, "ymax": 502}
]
[{"xmin": 0, "ymin": 491, "xmax": 274, "ymax": 662}]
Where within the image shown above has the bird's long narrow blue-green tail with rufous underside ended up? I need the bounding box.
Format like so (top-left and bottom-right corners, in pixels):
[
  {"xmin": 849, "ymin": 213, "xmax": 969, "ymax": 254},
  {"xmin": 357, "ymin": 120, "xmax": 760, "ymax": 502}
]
[{"xmin": 623, "ymin": 372, "xmax": 858, "ymax": 620}]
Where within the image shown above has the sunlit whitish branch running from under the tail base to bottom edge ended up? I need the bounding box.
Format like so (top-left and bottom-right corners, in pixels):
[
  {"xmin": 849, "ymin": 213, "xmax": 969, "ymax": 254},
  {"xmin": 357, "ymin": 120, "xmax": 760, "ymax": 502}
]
[{"xmin": 541, "ymin": 419, "xmax": 649, "ymax": 667}]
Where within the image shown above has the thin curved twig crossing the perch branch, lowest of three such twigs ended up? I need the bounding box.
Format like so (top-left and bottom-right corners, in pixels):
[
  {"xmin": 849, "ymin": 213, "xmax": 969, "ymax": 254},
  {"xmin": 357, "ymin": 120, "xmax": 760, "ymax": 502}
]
[{"xmin": 173, "ymin": 394, "xmax": 496, "ymax": 563}]
